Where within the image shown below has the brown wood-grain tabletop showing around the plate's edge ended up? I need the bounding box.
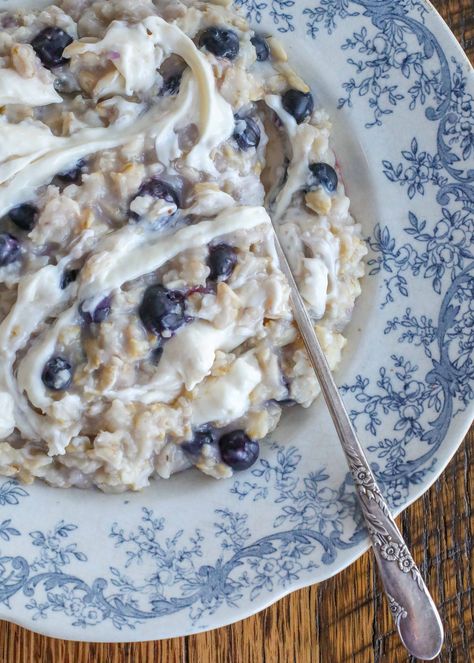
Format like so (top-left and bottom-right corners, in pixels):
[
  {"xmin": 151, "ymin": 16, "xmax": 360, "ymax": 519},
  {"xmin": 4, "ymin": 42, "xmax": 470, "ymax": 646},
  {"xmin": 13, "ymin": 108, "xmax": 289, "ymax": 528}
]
[{"xmin": 0, "ymin": 0, "xmax": 474, "ymax": 663}]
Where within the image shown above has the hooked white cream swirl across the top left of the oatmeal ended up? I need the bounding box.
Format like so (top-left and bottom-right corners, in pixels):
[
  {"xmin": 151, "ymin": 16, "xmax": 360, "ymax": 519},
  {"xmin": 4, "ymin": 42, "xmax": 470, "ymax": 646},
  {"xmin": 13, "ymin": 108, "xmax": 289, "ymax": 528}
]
[{"xmin": 0, "ymin": 16, "xmax": 234, "ymax": 215}]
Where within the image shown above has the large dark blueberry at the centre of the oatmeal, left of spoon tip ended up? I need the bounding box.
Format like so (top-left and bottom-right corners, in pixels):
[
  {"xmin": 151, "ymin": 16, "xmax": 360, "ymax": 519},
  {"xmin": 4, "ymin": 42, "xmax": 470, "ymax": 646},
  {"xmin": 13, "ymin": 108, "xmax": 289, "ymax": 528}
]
[{"xmin": 138, "ymin": 285, "xmax": 186, "ymax": 335}]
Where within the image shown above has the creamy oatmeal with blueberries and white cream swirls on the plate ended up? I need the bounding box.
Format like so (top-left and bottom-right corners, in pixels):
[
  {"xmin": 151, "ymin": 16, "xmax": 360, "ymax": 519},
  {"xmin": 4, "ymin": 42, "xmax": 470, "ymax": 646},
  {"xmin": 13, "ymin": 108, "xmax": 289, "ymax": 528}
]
[{"xmin": 0, "ymin": 0, "xmax": 365, "ymax": 491}]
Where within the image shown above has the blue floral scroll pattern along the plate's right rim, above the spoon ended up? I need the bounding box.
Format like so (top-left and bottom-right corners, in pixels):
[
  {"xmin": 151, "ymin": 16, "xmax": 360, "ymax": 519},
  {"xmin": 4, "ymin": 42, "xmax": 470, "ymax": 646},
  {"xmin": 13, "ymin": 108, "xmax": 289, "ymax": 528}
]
[{"xmin": 302, "ymin": 0, "xmax": 474, "ymax": 506}]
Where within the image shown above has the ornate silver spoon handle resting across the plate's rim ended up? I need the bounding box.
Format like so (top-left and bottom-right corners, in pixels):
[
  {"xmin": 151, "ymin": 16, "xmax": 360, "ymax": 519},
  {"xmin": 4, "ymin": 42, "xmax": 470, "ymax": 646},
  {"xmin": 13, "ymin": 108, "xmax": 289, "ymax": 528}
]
[{"xmin": 275, "ymin": 233, "xmax": 444, "ymax": 660}]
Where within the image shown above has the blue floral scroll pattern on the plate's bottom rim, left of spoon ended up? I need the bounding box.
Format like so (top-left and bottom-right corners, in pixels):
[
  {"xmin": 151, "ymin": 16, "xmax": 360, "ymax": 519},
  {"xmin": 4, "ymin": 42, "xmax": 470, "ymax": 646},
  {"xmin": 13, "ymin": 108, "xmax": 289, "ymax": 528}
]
[{"xmin": 0, "ymin": 454, "xmax": 365, "ymax": 630}]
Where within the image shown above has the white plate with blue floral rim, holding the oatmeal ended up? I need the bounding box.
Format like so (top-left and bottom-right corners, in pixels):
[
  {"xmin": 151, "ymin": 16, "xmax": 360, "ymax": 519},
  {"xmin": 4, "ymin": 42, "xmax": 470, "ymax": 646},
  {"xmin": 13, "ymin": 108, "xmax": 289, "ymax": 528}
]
[{"xmin": 0, "ymin": 0, "xmax": 474, "ymax": 641}]
